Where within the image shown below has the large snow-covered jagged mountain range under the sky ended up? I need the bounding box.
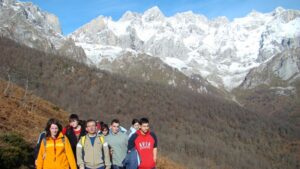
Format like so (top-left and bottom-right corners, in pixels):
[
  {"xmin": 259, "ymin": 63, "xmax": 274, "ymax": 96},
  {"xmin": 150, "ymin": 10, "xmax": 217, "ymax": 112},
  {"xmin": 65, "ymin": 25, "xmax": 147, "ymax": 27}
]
[{"xmin": 69, "ymin": 7, "xmax": 300, "ymax": 91}]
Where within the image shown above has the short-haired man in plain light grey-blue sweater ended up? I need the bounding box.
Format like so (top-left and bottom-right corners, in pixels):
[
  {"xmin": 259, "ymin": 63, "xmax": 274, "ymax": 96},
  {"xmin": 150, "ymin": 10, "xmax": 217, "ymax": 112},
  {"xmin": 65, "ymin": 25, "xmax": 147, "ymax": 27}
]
[{"xmin": 105, "ymin": 119, "xmax": 128, "ymax": 169}]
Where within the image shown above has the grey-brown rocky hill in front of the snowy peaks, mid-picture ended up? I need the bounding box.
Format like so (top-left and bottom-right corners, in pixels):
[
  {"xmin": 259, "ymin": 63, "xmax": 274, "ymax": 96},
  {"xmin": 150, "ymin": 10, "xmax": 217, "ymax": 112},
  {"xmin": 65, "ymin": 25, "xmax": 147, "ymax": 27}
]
[{"xmin": 100, "ymin": 52, "xmax": 224, "ymax": 97}]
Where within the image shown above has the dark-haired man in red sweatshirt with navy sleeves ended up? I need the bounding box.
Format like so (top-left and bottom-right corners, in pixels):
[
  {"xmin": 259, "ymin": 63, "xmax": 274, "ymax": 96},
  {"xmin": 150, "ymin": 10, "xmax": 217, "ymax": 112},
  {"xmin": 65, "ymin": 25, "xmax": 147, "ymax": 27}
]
[{"xmin": 128, "ymin": 118, "xmax": 157, "ymax": 169}]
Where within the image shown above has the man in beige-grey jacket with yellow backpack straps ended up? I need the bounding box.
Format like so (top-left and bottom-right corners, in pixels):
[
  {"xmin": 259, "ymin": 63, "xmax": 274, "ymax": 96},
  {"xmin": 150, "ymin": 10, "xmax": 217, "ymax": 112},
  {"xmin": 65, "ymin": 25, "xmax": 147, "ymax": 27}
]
[{"xmin": 76, "ymin": 120, "xmax": 111, "ymax": 169}]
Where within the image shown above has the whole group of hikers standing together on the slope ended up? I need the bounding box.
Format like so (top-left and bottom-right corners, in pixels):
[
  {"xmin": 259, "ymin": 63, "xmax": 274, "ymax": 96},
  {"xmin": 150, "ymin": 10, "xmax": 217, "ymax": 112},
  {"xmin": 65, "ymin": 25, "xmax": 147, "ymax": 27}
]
[{"xmin": 35, "ymin": 114, "xmax": 157, "ymax": 169}]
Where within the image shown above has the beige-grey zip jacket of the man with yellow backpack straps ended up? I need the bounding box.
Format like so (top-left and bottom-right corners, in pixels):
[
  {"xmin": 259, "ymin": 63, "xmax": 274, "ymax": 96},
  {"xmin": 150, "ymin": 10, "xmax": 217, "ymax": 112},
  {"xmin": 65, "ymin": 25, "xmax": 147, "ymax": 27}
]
[{"xmin": 76, "ymin": 134, "xmax": 111, "ymax": 169}]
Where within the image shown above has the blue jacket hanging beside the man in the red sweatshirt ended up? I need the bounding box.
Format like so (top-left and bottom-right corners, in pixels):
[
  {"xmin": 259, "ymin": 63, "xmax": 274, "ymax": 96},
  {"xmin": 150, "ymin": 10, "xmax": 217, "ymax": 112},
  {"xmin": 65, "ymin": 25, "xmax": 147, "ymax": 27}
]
[{"xmin": 122, "ymin": 148, "xmax": 140, "ymax": 169}]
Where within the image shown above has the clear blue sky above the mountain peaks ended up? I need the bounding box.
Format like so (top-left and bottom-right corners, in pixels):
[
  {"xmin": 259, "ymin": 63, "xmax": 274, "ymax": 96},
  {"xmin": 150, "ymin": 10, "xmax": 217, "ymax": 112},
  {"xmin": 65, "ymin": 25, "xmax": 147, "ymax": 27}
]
[{"xmin": 22, "ymin": 0, "xmax": 300, "ymax": 34}]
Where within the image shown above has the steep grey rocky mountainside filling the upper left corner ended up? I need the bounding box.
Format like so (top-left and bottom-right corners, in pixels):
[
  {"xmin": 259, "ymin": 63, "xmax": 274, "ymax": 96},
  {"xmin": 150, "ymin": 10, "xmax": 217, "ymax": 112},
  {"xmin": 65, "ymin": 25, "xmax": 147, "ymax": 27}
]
[{"xmin": 0, "ymin": 0, "xmax": 87, "ymax": 62}]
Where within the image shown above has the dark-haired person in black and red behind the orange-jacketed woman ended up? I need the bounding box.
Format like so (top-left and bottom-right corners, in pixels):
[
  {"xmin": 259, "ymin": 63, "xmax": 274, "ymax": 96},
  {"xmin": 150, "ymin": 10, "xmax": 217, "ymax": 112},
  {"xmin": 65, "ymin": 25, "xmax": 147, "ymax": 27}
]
[{"xmin": 62, "ymin": 114, "xmax": 86, "ymax": 160}]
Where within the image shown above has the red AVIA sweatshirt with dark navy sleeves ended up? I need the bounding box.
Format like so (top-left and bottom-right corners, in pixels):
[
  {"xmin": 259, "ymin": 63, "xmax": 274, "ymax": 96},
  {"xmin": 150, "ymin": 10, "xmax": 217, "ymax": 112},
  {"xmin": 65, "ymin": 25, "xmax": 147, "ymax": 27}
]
[{"xmin": 128, "ymin": 130, "xmax": 157, "ymax": 169}]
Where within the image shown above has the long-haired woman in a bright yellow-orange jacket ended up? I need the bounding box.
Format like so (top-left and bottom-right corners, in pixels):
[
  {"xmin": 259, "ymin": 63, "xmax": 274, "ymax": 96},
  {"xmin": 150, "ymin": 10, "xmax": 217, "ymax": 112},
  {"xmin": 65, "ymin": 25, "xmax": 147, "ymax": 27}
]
[{"xmin": 37, "ymin": 119, "xmax": 77, "ymax": 169}]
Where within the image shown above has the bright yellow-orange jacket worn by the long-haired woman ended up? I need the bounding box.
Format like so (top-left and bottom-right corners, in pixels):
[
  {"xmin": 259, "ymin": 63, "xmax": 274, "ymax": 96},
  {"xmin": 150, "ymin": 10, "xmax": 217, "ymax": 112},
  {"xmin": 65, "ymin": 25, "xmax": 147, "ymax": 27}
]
[{"xmin": 37, "ymin": 133, "xmax": 77, "ymax": 169}]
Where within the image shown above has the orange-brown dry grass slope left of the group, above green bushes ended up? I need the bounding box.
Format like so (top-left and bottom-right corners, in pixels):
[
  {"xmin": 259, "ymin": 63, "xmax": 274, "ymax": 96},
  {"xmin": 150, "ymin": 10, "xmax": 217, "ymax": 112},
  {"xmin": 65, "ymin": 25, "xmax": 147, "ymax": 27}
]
[{"xmin": 0, "ymin": 80, "xmax": 69, "ymax": 143}]
